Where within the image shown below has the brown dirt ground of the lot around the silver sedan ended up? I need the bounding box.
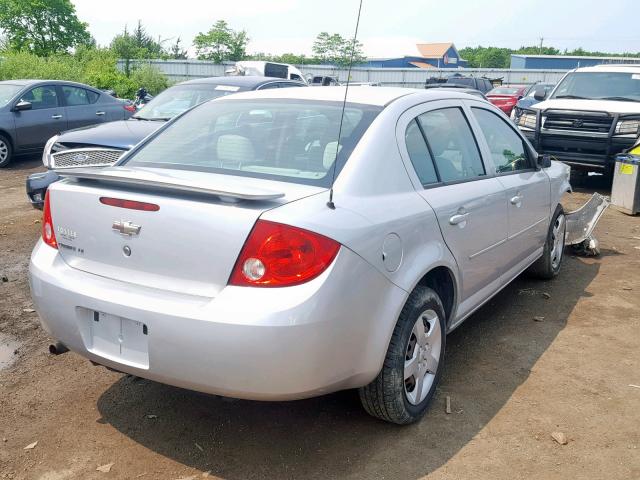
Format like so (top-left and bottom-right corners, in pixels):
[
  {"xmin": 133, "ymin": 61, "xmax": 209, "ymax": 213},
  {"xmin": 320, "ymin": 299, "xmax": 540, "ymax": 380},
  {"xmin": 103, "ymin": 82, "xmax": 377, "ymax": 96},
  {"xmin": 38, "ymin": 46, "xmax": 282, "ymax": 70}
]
[{"xmin": 0, "ymin": 159, "xmax": 640, "ymax": 480}]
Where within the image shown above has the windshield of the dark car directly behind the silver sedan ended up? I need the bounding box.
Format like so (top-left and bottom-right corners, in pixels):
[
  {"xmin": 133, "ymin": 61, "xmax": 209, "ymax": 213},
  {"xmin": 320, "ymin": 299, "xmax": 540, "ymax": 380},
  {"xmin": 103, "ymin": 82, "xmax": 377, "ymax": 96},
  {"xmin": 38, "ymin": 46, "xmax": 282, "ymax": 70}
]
[{"xmin": 133, "ymin": 83, "xmax": 246, "ymax": 120}]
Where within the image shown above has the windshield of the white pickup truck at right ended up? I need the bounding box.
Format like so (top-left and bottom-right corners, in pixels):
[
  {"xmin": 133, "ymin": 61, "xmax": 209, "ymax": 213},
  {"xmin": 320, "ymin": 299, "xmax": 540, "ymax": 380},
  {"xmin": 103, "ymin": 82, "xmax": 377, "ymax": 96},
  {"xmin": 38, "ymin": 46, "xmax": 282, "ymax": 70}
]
[{"xmin": 551, "ymin": 72, "xmax": 640, "ymax": 102}]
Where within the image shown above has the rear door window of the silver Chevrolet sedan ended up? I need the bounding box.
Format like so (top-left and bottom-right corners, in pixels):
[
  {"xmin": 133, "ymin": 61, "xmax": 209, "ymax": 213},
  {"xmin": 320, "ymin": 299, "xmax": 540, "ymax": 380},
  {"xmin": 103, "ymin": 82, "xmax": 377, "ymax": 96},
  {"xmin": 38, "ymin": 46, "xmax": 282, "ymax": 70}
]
[{"xmin": 418, "ymin": 107, "xmax": 486, "ymax": 182}]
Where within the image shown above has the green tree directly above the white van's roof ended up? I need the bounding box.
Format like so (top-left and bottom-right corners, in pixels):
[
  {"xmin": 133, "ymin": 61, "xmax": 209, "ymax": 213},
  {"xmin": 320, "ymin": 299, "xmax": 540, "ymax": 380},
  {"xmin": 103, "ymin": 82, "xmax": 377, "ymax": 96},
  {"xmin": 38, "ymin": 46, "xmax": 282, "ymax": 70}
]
[{"xmin": 193, "ymin": 20, "xmax": 249, "ymax": 63}]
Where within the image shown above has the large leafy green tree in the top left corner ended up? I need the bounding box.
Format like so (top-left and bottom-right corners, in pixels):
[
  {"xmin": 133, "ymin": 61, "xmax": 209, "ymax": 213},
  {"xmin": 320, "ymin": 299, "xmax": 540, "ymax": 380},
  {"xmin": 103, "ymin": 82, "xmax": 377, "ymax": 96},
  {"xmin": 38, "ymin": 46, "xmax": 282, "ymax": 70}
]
[{"xmin": 0, "ymin": 0, "xmax": 91, "ymax": 56}]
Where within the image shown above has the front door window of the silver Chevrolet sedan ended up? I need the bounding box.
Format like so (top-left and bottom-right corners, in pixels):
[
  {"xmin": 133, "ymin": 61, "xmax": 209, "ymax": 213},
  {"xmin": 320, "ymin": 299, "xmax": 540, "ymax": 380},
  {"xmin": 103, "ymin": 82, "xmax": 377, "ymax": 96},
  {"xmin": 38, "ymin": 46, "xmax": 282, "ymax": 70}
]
[{"xmin": 472, "ymin": 107, "xmax": 532, "ymax": 173}]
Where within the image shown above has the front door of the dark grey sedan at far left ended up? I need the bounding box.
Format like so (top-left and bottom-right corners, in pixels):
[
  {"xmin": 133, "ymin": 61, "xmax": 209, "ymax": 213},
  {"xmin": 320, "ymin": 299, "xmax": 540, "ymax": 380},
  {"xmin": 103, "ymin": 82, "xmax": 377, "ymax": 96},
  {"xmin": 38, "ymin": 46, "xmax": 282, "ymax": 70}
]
[{"xmin": 13, "ymin": 85, "xmax": 67, "ymax": 150}]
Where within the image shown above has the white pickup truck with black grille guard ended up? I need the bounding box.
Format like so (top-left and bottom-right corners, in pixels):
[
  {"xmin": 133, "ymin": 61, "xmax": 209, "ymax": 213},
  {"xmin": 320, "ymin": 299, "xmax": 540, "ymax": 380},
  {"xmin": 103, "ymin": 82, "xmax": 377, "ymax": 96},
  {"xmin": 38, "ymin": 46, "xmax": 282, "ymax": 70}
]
[{"xmin": 517, "ymin": 64, "xmax": 640, "ymax": 180}]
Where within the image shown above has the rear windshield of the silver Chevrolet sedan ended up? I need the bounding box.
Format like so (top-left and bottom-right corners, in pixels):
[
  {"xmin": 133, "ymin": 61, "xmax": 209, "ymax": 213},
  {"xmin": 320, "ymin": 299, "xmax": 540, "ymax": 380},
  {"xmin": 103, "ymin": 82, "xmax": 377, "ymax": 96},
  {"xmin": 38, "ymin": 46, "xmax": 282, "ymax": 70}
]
[{"xmin": 127, "ymin": 99, "xmax": 381, "ymax": 187}]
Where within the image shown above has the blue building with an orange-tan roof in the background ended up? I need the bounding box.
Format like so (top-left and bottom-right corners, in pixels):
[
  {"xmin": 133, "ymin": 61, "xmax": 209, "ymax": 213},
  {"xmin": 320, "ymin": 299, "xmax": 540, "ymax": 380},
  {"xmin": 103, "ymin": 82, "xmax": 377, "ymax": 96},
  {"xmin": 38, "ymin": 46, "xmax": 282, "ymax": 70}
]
[{"xmin": 360, "ymin": 43, "xmax": 467, "ymax": 68}]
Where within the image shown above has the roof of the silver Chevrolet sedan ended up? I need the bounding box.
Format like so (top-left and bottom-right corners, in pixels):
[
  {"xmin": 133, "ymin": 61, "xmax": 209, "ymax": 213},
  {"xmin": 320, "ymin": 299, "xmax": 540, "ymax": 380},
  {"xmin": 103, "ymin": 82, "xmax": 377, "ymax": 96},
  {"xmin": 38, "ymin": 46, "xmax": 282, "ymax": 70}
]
[{"xmin": 214, "ymin": 86, "xmax": 456, "ymax": 107}]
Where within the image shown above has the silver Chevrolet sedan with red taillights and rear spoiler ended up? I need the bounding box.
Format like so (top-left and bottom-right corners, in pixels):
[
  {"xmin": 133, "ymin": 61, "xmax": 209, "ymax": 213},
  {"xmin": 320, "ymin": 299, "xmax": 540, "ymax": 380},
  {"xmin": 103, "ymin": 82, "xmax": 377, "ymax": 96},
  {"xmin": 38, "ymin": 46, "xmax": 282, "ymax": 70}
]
[{"xmin": 30, "ymin": 87, "xmax": 570, "ymax": 424}]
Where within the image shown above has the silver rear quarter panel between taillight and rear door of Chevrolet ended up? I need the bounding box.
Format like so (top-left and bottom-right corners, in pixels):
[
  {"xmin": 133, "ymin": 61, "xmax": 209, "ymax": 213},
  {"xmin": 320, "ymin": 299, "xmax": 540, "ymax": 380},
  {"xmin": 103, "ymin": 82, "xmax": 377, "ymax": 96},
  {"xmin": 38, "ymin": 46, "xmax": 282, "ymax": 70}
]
[{"xmin": 261, "ymin": 104, "xmax": 459, "ymax": 336}]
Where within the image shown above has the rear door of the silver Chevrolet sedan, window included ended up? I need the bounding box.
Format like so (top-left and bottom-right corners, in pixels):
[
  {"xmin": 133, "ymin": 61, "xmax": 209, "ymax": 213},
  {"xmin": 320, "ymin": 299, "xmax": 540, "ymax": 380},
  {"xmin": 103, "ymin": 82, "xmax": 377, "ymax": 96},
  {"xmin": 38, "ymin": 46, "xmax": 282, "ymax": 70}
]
[{"xmin": 405, "ymin": 101, "xmax": 508, "ymax": 318}]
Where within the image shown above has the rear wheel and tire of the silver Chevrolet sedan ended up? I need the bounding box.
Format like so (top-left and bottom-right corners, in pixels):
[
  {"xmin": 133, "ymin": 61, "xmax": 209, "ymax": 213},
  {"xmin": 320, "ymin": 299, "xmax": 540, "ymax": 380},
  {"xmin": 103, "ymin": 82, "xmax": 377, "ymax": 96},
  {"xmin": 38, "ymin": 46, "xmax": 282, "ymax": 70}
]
[{"xmin": 359, "ymin": 286, "xmax": 446, "ymax": 425}]
